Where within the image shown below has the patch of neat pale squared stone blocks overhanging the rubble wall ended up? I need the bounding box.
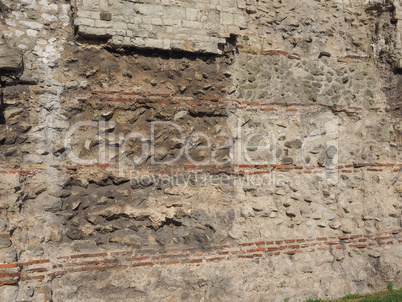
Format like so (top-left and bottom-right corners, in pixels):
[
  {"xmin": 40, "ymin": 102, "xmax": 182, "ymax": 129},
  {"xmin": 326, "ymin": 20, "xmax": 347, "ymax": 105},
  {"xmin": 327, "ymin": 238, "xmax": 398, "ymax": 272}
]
[{"xmin": 74, "ymin": 0, "xmax": 246, "ymax": 54}]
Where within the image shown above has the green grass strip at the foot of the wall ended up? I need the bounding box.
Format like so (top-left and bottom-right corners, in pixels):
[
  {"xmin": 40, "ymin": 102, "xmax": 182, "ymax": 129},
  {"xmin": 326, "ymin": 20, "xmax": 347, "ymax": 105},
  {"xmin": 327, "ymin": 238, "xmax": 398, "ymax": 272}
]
[{"xmin": 307, "ymin": 283, "xmax": 402, "ymax": 302}]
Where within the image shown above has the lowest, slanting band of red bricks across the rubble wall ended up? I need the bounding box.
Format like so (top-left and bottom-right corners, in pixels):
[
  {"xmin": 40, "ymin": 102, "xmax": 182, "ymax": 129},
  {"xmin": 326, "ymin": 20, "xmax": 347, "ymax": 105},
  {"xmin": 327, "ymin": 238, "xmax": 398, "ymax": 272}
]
[{"xmin": 0, "ymin": 229, "xmax": 402, "ymax": 285}]
